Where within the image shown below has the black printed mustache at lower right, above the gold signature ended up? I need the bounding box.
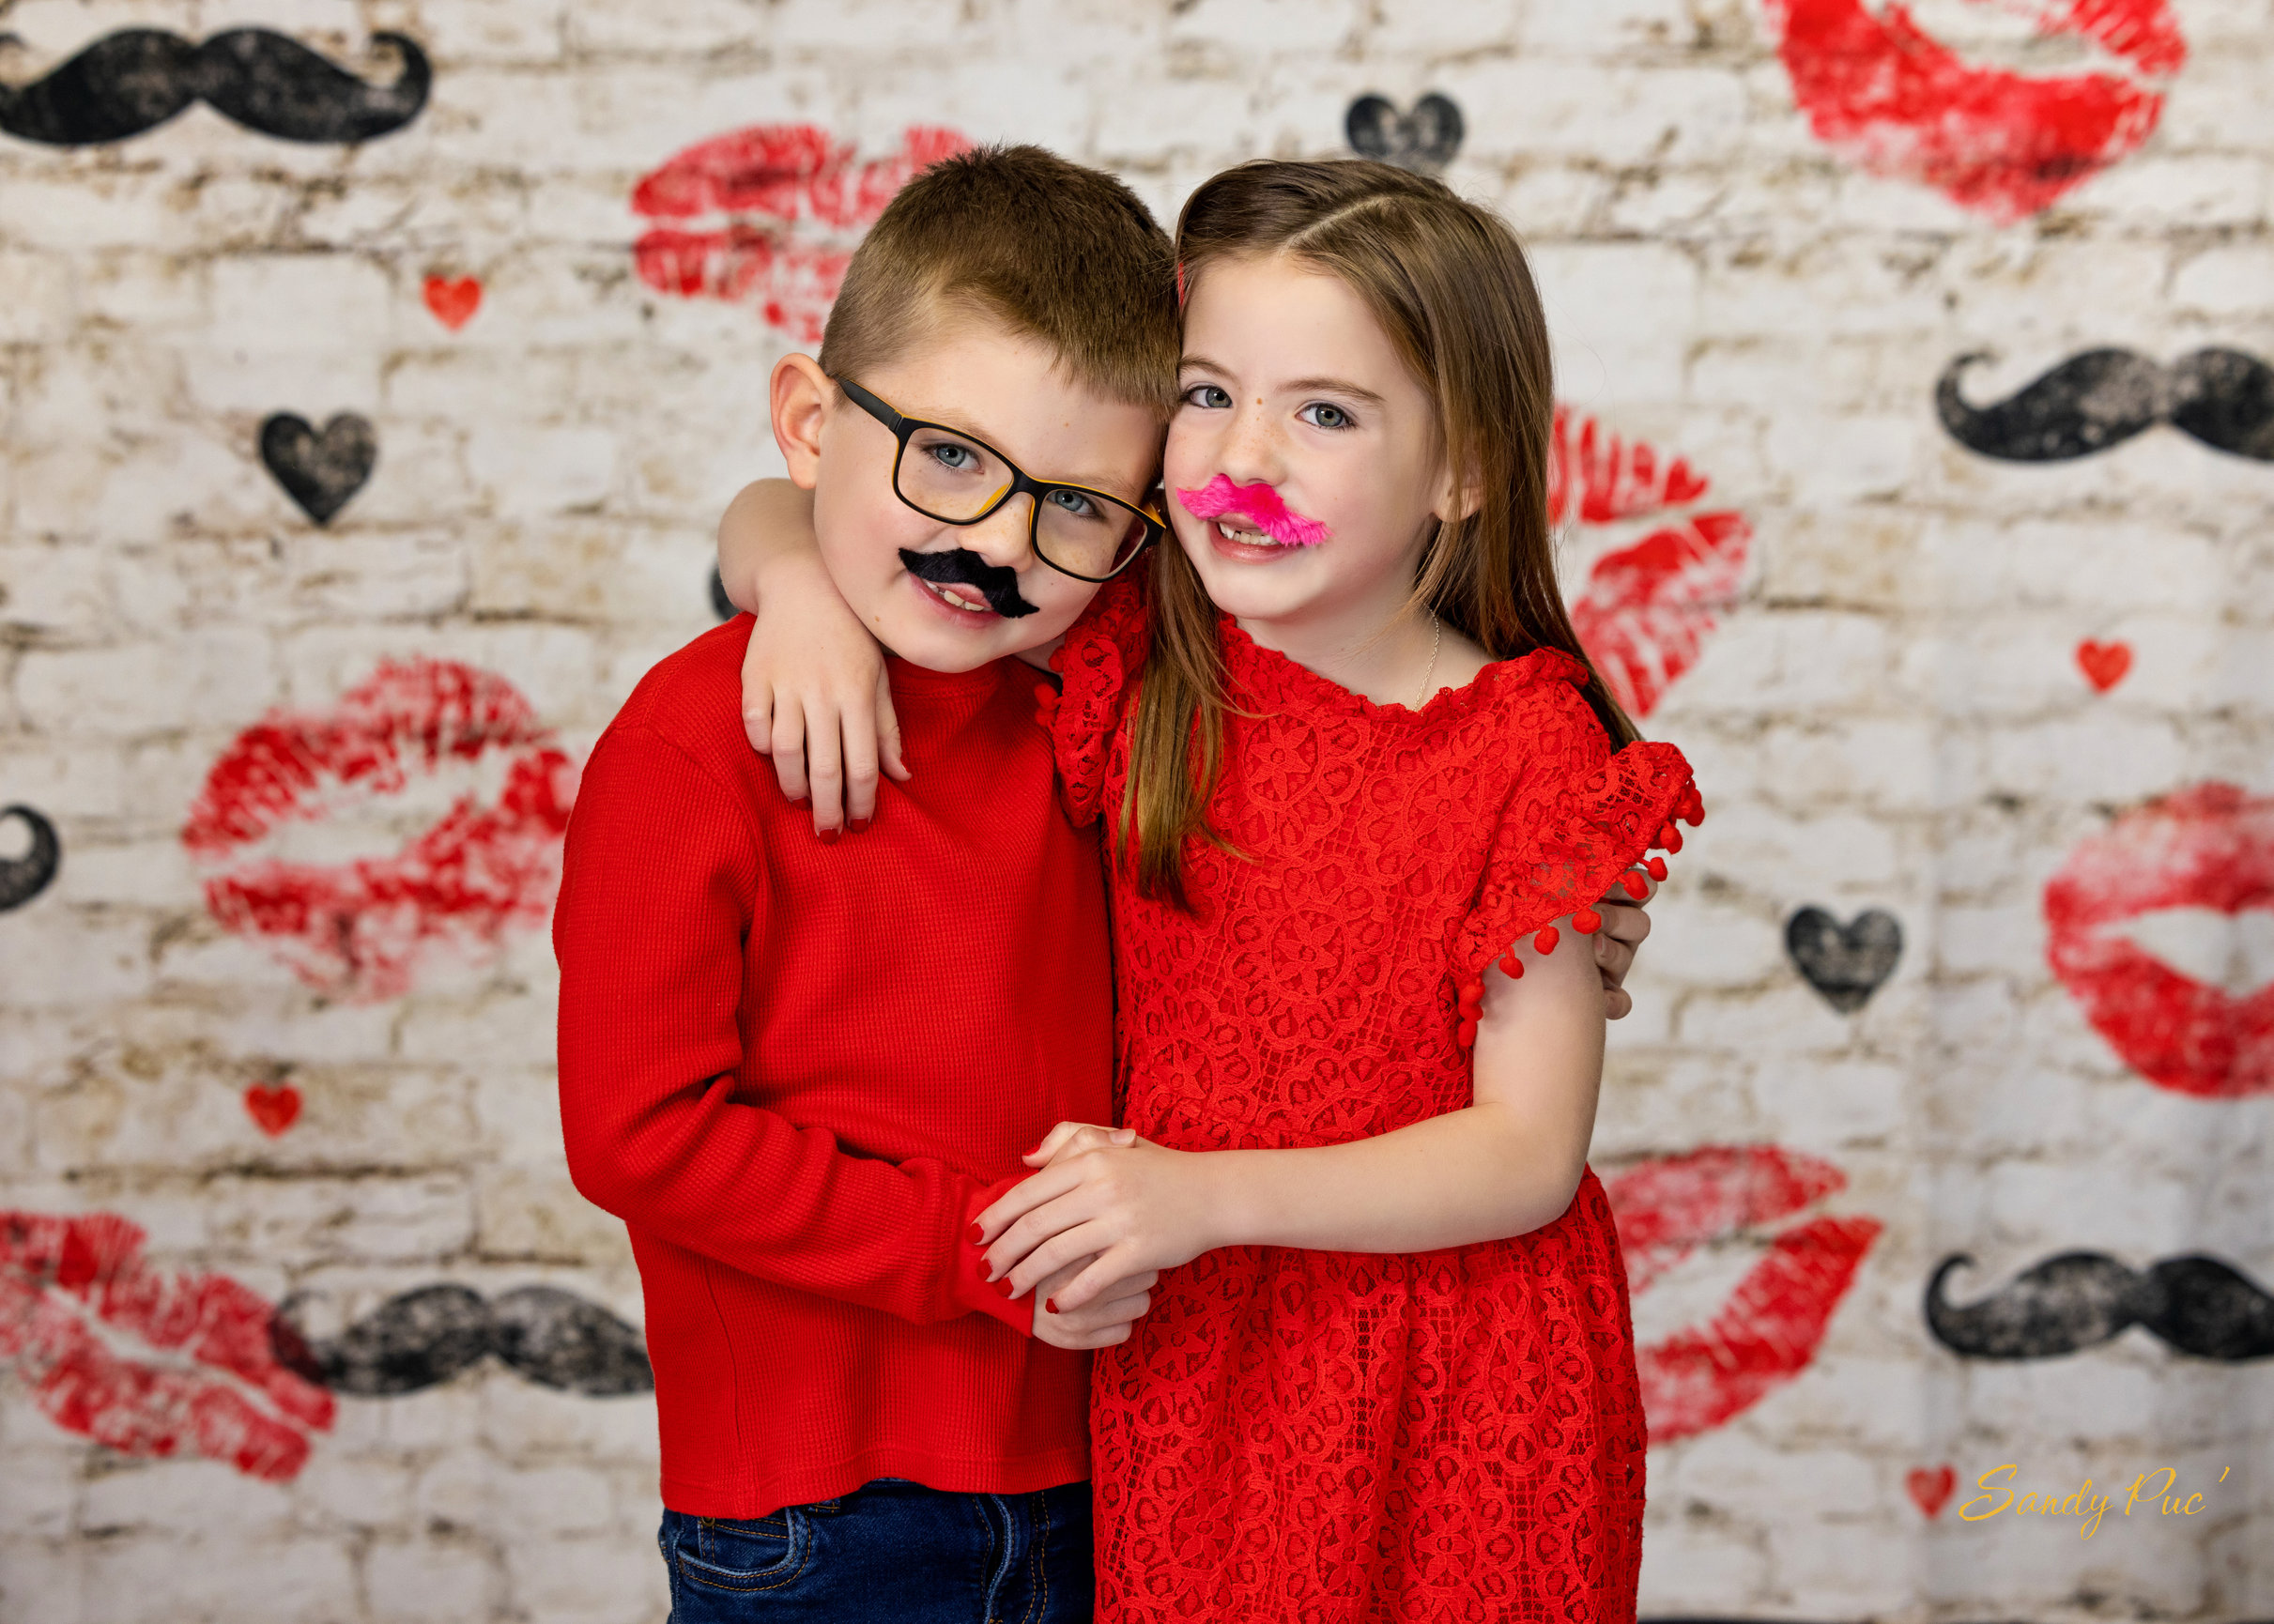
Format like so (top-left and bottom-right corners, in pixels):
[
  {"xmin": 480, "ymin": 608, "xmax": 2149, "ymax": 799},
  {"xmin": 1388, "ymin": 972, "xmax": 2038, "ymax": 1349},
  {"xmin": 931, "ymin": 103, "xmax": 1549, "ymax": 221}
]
[{"xmin": 1926, "ymin": 1251, "xmax": 2274, "ymax": 1362}]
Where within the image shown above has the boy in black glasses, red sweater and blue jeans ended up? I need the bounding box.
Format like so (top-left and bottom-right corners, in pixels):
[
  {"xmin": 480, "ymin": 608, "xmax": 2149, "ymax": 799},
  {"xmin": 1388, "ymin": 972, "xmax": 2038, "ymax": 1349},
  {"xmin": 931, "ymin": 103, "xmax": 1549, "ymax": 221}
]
[{"xmin": 555, "ymin": 147, "xmax": 1178, "ymax": 1624}]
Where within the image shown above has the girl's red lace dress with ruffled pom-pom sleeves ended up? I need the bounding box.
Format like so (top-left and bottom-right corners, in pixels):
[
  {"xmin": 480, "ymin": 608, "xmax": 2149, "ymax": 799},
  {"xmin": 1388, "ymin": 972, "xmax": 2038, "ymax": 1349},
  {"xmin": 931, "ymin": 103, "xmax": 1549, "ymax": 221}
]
[{"xmin": 1055, "ymin": 582, "xmax": 1692, "ymax": 1624}]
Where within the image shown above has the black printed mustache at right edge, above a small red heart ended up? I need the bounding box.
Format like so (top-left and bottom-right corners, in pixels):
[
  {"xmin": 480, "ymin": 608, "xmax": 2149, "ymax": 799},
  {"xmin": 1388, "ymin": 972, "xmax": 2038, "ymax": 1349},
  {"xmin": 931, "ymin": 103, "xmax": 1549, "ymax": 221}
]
[{"xmin": 1935, "ymin": 350, "xmax": 2274, "ymax": 462}]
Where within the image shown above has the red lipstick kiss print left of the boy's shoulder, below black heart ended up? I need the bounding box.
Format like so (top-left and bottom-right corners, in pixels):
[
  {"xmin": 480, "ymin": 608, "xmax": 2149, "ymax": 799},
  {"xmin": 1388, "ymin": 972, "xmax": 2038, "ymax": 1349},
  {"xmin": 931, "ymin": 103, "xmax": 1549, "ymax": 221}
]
[{"xmin": 182, "ymin": 660, "xmax": 576, "ymax": 1004}]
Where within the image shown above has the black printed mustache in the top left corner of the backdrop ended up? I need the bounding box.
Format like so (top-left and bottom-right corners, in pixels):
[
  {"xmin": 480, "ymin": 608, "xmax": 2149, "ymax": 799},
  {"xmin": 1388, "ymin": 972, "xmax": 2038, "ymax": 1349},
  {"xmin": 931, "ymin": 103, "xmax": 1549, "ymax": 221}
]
[{"xmin": 0, "ymin": 27, "xmax": 435, "ymax": 146}]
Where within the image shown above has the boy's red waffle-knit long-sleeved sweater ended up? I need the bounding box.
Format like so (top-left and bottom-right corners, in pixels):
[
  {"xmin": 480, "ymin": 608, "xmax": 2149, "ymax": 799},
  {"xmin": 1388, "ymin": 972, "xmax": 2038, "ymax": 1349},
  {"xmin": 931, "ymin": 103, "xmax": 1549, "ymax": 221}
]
[{"xmin": 553, "ymin": 619, "xmax": 1112, "ymax": 1517}]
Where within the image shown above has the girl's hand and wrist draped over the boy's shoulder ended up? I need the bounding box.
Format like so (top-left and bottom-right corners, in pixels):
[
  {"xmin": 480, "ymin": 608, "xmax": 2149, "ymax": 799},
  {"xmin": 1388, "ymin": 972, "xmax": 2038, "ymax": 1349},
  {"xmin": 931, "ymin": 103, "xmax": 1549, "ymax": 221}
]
[{"xmin": 718, "ymin": 480, "xmax": 907, "ymax": 839}]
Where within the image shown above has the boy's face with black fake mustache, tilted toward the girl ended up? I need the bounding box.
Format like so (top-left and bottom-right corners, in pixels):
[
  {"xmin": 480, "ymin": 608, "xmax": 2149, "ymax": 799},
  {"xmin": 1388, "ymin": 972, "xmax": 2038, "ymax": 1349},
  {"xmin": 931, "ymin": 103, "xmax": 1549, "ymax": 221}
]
[{"xmin": 776, "ymin": 316, "xmax": 1162, "ymax": 671}]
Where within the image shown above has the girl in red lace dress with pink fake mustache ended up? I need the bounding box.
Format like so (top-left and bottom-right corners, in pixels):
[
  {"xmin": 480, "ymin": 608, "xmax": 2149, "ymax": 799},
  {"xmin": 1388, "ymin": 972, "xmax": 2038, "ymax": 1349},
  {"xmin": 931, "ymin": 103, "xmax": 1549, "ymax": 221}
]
[{"xmin": 718, "ymin": 161, "xmax": 1701, "ymax": 1624}]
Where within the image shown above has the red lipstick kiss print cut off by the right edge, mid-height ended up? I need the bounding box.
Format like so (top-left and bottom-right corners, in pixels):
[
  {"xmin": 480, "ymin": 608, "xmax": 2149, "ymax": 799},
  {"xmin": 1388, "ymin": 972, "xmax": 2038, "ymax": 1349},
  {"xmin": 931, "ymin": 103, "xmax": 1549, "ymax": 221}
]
[{"xmin": 2044, "ymin": 783, "xmax": 2274, "ymax": 1098}]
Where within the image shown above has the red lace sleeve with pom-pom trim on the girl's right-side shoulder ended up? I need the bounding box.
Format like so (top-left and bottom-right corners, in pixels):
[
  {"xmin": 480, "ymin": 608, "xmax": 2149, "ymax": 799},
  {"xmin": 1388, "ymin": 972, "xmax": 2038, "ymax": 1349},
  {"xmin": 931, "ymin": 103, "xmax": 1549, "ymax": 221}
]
[{"xmin": 1451, "ymin": 694, "xmax": 1706, "ymax": 1044}]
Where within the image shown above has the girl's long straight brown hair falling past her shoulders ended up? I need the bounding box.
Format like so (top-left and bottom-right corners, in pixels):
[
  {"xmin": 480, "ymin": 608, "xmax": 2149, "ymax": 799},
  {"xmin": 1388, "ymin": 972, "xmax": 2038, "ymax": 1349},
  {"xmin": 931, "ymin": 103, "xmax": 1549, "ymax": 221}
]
[{"xmin": 1114, "ymin": 160, "xmax": 1637, "ymax": 910}]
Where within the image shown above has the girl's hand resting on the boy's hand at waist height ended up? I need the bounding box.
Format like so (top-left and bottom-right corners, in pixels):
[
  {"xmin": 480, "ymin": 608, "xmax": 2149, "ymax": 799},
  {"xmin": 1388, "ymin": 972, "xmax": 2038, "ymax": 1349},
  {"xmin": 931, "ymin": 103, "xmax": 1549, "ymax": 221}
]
[{"xmin": 977, "ymin": 1124, "xmax": 1219, "ymax": 1312}]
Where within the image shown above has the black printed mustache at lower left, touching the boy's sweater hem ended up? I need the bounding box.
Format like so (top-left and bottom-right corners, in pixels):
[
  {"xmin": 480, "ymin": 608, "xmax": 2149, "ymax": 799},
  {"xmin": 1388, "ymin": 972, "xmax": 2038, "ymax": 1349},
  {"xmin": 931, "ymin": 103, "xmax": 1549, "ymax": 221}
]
[{"xmin": 269, "ymin": 1285, "xmax": 655, "ymax": 1399}]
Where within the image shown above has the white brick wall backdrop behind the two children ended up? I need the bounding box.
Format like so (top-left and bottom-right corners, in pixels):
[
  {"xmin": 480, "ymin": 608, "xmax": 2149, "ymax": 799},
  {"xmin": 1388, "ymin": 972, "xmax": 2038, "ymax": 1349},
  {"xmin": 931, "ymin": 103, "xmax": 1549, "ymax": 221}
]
[{"xmin": 0, "ymin": 0, "xmax": 2274, "ymax": 1624}]
